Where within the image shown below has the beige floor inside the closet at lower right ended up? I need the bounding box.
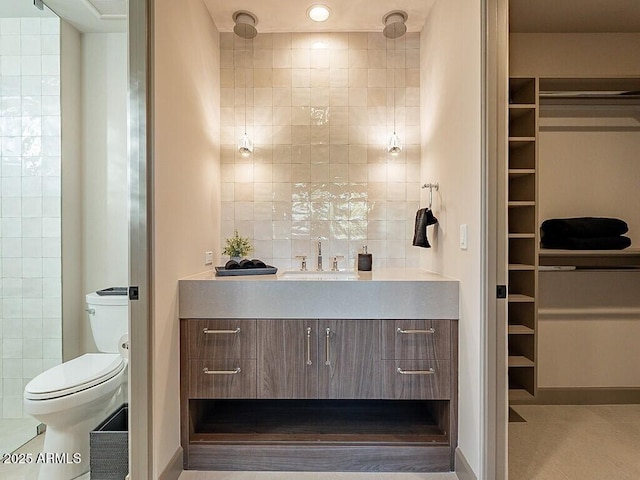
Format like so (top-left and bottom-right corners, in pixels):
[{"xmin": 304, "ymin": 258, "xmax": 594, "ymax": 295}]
[{"xmin": 509, "ymin": 405, "xmax": 640, "ymax": 480}]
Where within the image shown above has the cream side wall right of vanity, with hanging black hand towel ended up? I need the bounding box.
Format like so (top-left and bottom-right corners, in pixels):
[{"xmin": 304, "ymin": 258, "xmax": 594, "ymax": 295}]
[{"xmin": 420, "ymin": 0, "xmax": 483, "ymax": 474}]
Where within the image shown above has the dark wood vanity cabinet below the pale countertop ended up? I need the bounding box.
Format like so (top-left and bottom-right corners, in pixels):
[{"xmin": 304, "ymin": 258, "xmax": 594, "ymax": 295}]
[{"xmin": 181, "ymin": 319, "xmax": 458, "ymax": 472}]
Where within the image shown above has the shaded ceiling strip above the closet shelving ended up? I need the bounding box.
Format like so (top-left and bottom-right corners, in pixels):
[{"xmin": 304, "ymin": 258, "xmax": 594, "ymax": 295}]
[{"xmin": 509, "ymin": 0, "xmax": 640, "ymax": 33}]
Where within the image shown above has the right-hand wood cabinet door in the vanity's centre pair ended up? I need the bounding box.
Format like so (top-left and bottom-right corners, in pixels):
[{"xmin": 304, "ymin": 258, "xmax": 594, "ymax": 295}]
[{"xmin": 318, "ymin": 320, "xmax": 381, "ymax": 398}]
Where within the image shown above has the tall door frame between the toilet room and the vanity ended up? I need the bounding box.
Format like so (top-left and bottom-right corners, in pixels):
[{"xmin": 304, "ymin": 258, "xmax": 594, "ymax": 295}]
[{"xmin": 128, "ymin": 0, "xmax": 153, "ymax": 480}]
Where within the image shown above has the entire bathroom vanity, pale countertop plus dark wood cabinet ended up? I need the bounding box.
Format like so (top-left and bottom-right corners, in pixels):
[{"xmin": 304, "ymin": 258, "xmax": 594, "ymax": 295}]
[{"xmin": 179, "ymin": 269, "xmax": 458, "ymax": 472}]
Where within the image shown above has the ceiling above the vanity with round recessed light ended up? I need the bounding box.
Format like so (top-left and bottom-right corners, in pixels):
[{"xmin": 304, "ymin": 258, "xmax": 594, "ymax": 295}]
[{"xmin": 204, "ymin": 0, "xmax": 438, "ymax": 33}]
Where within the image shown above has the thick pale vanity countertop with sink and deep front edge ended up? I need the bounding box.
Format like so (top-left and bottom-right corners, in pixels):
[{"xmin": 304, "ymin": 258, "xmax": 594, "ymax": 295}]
[{"xmin": 179, "ymin": 268, "xmax": 459, "ymax": 319}]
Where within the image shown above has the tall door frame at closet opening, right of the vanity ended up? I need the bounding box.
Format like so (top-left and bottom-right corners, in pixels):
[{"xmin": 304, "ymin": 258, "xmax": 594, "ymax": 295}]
[{"xmin": 479, "ymin": 0, "xmax": 509, "ymax": 480}]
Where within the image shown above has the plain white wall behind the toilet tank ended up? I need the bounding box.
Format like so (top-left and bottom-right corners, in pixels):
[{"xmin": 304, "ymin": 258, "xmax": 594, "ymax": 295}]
[{"xmin": 81, "ymin": 33, "xmax": 129, "ymax": 351}]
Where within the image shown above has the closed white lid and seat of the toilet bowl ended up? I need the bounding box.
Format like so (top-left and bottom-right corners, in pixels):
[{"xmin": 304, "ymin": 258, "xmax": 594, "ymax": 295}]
[{"xmin": 24, "ymin": 353, "xmax": 125, "ymax": 400}]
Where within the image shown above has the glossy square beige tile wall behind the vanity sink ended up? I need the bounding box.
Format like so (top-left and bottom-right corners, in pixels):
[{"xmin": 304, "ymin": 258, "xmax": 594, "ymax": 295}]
[{"xmin": 220, "ymin": 32, "xmax": 421, "ymax": 269}]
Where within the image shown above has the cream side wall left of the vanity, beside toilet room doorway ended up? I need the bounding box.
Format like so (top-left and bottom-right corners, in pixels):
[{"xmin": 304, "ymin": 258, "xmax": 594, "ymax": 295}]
[{"xmin": 151, "ymin": 0, "xmax": 220, "ymax": 478}]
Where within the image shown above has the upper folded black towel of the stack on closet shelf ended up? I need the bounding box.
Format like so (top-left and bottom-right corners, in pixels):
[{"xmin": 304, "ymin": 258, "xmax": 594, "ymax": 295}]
[{"xmin": 540, "ymin": 217, "xmax": 629, "ymax": 239}]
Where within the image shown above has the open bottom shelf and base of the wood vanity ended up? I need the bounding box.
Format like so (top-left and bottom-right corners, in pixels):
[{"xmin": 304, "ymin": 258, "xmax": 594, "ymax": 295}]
[{"xmin": 189, "ymin": 399, "xmax": 451, "ymax": 471}]
